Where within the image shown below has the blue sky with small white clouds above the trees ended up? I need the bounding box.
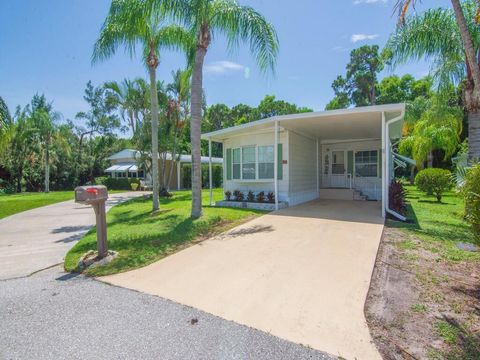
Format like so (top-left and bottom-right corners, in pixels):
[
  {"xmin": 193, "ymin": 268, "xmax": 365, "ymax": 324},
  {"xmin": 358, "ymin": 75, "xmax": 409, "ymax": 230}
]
[{"xmin": 0, "ymin": 0, "xmax": 449, "ymax": 119}]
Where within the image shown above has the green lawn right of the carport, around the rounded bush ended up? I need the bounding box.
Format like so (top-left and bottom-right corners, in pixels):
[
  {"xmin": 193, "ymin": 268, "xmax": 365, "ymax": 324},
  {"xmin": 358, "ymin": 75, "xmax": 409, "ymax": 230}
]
[{"xmin": 387, "ymin": 185, "xmax": 480, "ymax": 261}]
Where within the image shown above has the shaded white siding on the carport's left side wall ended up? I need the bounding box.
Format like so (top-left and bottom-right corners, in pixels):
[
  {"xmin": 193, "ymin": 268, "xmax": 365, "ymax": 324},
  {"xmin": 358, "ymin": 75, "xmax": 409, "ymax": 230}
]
[{"xmin": 288, "ymin": 131, "xmax": 318, "ymax": 205}]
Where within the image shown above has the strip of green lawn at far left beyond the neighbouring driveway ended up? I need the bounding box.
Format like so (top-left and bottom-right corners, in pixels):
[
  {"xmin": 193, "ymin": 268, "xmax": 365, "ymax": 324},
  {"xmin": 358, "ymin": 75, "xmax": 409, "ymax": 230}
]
[{"xmin": 0, "ymin": 190, "xmax": 73, "ymax": 219}]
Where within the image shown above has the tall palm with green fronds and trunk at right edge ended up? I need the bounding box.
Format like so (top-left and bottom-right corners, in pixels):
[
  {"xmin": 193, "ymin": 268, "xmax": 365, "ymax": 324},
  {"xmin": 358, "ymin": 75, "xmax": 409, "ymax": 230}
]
[{"xmin": 389, "ymin": 0, "xmax": 480, "ymax": 161}]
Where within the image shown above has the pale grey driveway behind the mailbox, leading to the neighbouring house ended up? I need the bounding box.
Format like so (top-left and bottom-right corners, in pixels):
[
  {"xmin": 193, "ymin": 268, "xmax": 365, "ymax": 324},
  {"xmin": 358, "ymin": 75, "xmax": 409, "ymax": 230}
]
[{"xmin": 0, "ymin": 192, "xmax": 148, "ymax": 280}]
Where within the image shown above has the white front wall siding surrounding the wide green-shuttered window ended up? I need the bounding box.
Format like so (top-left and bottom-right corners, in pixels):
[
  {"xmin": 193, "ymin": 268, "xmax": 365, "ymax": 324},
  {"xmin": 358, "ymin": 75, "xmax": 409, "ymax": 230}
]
[{"xmin": 223, "ymin": 129, "xmax": 290, "ymax": 201}]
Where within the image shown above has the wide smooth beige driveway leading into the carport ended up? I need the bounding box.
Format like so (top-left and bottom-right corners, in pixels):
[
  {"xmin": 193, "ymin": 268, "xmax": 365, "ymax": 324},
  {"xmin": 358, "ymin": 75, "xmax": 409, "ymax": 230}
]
[{"xmin": 102, "ymin": 200, "xmax": 383, "ymax": 360}]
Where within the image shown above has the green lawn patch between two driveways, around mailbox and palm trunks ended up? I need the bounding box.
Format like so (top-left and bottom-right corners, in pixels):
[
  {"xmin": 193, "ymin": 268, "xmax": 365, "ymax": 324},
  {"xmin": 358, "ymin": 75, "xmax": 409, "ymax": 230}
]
[{"xmin": 65, "ymin": 189, "xmax": 264, "ymax": 276}]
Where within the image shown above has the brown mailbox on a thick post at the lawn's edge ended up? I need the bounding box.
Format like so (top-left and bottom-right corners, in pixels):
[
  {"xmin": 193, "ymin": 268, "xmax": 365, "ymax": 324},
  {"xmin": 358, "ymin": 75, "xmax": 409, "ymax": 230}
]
[{"xmin": 75, "ymin": 185, "xmax": 108, "ymax": 259}]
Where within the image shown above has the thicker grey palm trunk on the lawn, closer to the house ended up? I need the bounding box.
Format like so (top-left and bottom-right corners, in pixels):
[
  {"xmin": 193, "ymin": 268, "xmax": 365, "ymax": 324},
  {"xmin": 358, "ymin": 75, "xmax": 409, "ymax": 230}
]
[{"xmin": 190, "ymin": 46, "xmax": 207, "ymax": 218}]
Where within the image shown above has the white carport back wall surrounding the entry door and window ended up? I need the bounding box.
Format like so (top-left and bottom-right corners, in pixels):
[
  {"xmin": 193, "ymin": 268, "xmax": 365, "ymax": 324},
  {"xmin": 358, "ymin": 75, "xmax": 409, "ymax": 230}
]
[{"xmin": 320, "ymin": 139, "xmax": 382, "ymax": 200}]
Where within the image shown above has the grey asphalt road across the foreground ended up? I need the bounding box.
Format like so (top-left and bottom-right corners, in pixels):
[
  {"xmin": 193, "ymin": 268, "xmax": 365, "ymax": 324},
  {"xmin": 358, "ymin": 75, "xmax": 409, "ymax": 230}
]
[{"xmin": 0, "ymin": 267, "xmax": 333, "ymax": 360}]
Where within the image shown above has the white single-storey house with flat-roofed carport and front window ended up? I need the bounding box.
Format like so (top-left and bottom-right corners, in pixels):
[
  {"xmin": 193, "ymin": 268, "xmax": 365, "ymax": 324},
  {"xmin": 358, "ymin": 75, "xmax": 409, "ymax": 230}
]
[{"xmin": 202, "ymin": 104, "xmax": 413, "ymax": 215}]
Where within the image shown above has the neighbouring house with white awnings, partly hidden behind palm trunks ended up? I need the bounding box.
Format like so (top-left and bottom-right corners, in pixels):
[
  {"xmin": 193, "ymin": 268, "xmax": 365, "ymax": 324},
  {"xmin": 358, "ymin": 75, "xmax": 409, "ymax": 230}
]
[{"xmin": 105, "ymin": 149, "xmax": 223, "ymax": 189}]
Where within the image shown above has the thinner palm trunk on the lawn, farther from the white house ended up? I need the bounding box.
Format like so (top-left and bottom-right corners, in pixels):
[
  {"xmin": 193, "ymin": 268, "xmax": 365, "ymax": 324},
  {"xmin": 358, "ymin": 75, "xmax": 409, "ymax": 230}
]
[{"xmin": 148, "ymin": 63, "xmax": 160, "ymax": 211}]
